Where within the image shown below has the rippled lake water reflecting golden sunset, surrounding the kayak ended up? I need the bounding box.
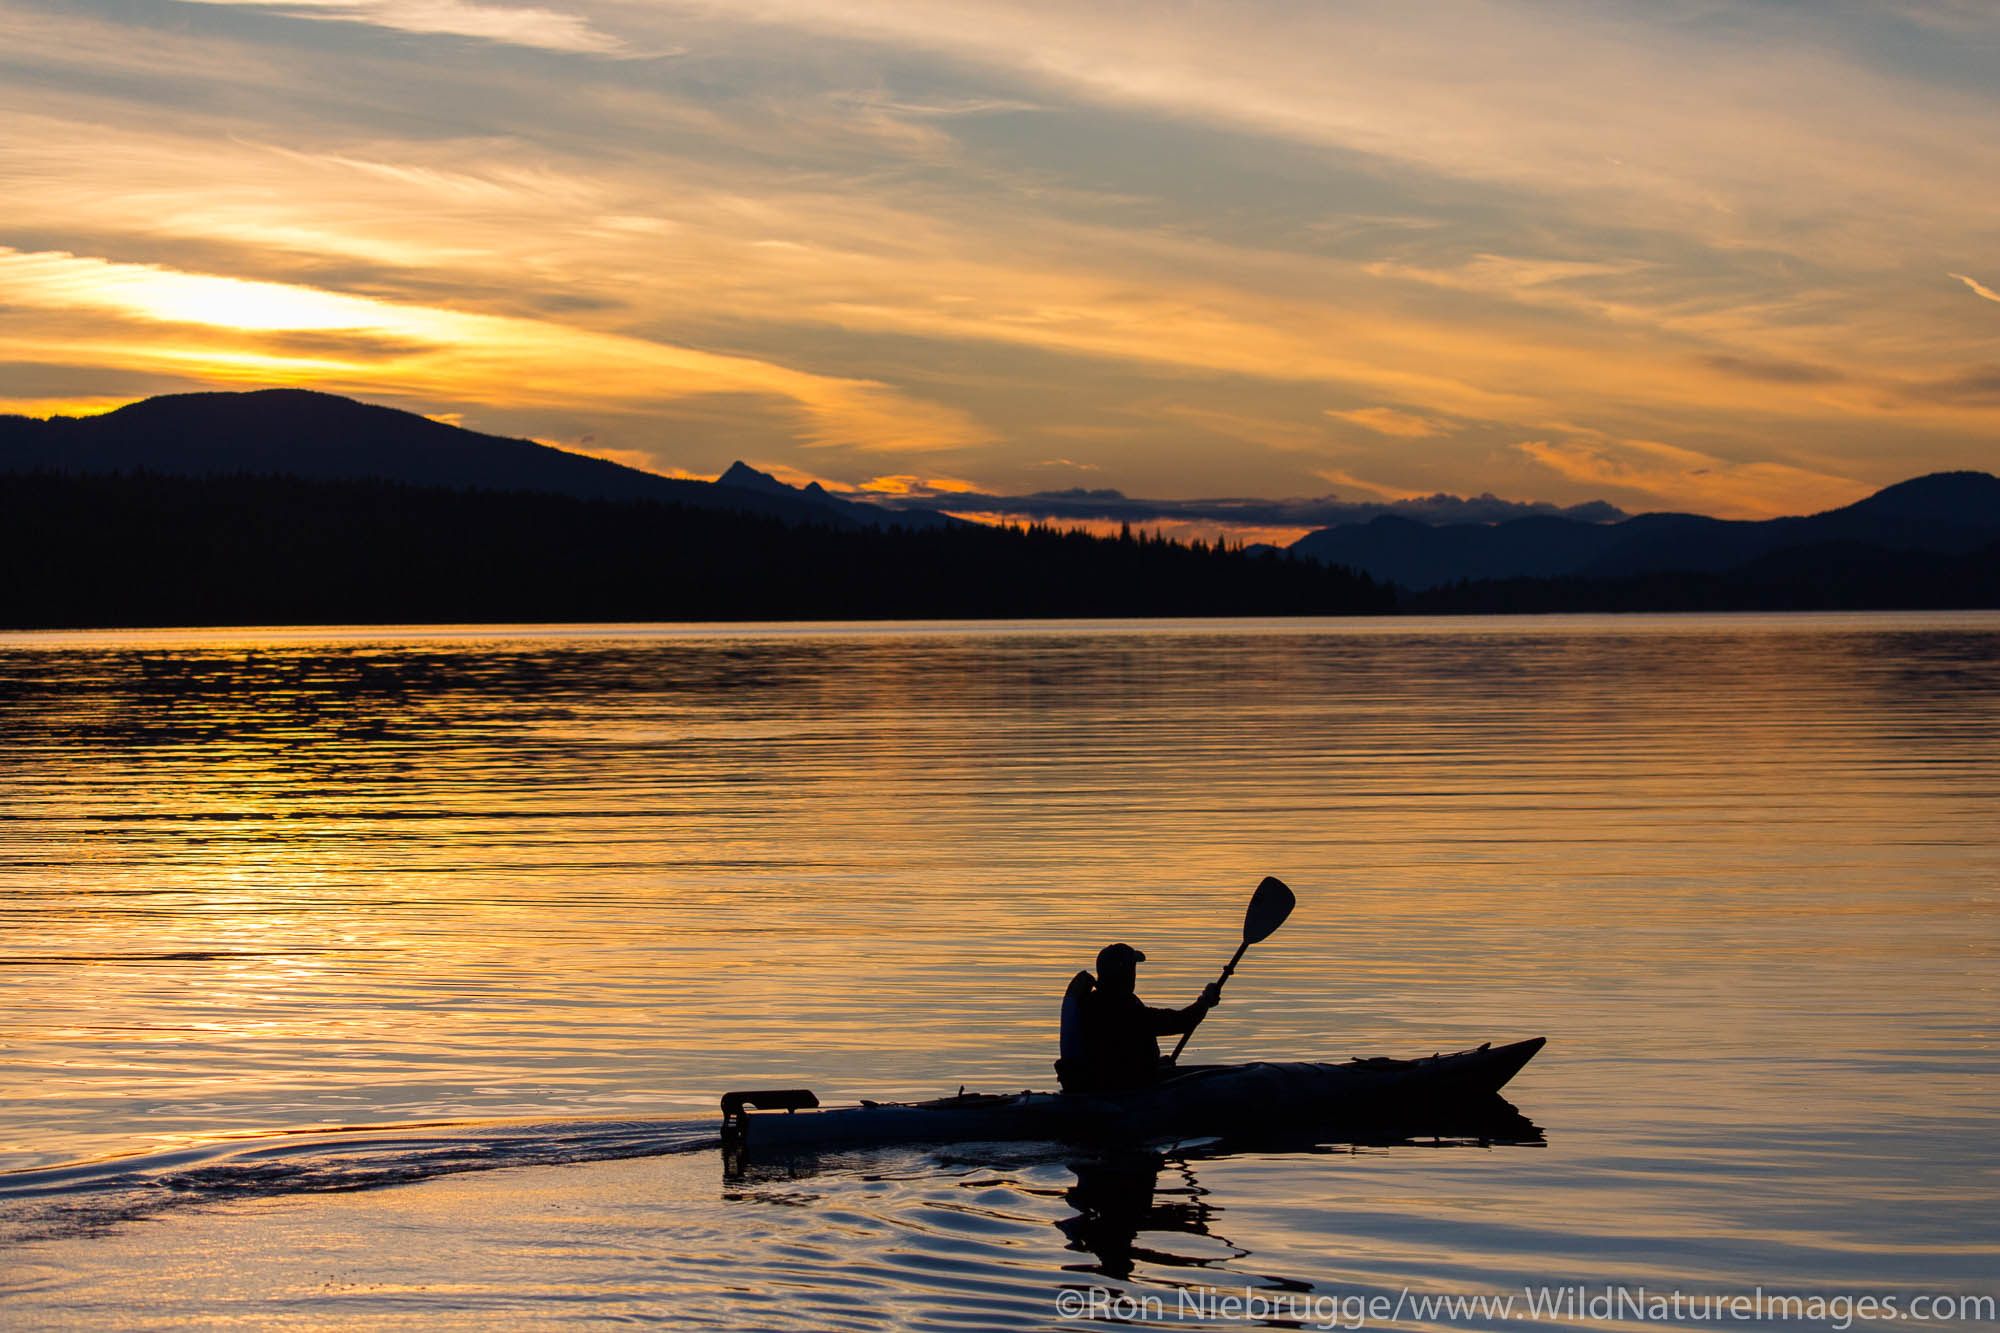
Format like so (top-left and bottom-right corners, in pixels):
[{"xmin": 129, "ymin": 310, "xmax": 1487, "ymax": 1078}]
[{"xmin": 0, "ymin": 614, "xmax": 2000, "ymax": 1329}]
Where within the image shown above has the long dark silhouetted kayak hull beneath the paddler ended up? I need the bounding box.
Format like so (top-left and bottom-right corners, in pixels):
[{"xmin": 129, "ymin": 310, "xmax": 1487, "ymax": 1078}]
[{"xmin": 722, "ymin": 1037, "xmax": 1548, "ymax": 1149}]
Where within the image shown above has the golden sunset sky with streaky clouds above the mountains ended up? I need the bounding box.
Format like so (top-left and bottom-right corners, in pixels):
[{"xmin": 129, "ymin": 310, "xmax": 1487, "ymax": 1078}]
[{"xmin": 0, "ymin": 0, "xmax": 2000, "ymax": 536}]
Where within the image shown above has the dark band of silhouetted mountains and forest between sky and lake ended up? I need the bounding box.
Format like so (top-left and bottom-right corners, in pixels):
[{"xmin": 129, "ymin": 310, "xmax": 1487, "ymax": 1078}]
[{"xmin": 0, "ymin": 390, "xmax": 2000, "ymax": 624}]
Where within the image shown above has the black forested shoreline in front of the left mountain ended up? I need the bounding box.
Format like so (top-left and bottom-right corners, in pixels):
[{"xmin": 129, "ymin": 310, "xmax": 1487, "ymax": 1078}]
[{"xmin": 0, "ymin": 472, "xmax": 1394, "ymax": 628}]
